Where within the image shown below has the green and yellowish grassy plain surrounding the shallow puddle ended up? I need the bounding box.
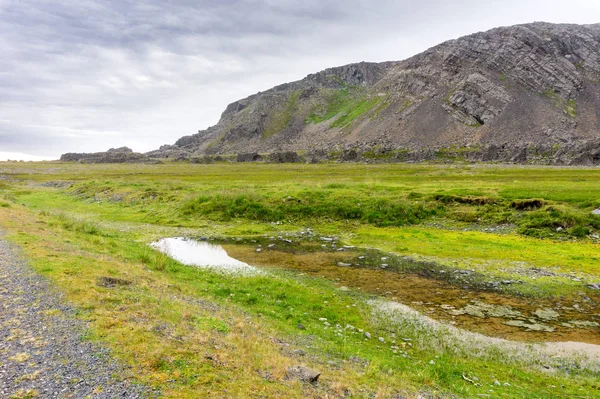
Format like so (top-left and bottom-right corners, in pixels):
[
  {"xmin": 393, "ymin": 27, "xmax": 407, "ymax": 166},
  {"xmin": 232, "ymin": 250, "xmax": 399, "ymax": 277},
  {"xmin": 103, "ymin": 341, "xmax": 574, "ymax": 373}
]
[{"xmin": 0, "ymin": 163, "xmax": 600, "ymax": 398}]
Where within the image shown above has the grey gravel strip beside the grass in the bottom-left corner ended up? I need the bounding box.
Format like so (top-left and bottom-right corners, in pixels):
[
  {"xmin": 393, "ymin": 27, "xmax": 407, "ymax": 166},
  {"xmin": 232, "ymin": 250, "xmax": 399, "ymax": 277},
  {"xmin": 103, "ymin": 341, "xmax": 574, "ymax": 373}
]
[{"xmin": 0, "ymin": 237, "xmax": 156, "ymax": 399}]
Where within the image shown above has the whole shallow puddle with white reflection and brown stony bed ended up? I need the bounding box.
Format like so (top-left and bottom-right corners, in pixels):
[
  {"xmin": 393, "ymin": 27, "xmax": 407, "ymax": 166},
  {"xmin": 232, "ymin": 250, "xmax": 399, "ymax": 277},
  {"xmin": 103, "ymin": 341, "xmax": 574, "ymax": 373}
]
[{"xmin": 152, "ymin": 238, "xmax": 600, "ymax": 344}]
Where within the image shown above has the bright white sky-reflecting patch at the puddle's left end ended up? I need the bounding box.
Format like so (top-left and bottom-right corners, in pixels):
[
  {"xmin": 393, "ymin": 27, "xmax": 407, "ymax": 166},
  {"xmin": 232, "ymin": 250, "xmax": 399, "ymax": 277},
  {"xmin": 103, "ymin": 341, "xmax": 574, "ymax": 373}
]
[{"xmin": 150, "ymin": 237, "xmax": 259, "ymax": 274}]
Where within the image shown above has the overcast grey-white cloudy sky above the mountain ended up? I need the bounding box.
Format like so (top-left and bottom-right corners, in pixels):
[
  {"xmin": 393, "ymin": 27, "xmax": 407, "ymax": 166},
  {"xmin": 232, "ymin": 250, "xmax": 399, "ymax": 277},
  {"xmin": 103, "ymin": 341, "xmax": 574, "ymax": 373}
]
[{"xmin": 0, "ymin": 0, "xmax": 600, "ymax": 160}]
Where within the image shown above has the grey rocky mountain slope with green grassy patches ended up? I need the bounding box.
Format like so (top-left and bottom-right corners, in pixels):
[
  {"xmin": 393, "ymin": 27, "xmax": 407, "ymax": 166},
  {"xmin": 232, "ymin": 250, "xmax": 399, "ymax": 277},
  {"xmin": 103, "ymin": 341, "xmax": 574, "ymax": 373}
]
[{"xmin": 157, "ymin": 23, "xmax": 600, "ymax": 163}]
